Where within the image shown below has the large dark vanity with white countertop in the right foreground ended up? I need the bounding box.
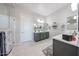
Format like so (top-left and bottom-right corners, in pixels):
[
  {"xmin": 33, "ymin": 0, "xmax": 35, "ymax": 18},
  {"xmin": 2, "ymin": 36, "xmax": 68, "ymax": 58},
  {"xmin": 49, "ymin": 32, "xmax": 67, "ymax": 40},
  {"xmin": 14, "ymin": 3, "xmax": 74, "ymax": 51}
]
[{"xmin": 53, "ymin": 34, "xmax": 79, "ymax": 56}]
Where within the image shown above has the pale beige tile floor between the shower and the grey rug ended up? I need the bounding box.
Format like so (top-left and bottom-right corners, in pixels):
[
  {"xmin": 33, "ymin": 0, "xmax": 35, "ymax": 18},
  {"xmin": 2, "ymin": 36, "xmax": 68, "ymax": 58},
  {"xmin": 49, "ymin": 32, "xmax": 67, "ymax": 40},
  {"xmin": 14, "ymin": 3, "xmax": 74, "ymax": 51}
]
[{"xmin": 9, "ymin": 39, "xmax": 52, "ymax": 56}]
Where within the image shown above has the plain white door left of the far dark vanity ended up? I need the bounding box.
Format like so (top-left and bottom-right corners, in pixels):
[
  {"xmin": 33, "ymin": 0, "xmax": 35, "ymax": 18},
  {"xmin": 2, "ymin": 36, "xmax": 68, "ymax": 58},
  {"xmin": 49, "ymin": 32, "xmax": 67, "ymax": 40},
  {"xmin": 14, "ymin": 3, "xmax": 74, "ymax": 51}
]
[{"xmin": 20, "ymin": 15, "xmax": 33, "ymax": 42}]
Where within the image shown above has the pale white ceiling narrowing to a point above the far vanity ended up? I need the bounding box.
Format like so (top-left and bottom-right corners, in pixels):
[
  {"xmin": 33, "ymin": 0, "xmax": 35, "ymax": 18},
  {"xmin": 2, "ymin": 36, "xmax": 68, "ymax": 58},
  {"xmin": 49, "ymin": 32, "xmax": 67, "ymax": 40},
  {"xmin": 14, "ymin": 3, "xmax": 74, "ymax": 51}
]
[{"xmin": 16, "ymin": 3, "xmax": 70, "ymax": 16}]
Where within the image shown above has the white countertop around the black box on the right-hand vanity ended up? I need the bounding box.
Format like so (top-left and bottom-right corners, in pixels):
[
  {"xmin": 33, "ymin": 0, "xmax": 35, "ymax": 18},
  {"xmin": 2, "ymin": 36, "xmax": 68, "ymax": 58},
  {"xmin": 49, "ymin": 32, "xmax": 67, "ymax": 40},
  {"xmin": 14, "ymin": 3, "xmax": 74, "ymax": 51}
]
[{"xmin": 53, "ymin": 34, "xmax": 79, "ymax": 47}]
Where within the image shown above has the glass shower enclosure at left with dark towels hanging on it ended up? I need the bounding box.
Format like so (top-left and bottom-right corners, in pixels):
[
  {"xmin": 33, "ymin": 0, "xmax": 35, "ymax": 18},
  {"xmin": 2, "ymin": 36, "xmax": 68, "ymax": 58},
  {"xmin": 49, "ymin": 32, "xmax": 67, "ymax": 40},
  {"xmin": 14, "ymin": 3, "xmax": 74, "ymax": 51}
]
[{"xmin": 0, "ymin": 3, "xmax": 14, "ymax": 56}]
